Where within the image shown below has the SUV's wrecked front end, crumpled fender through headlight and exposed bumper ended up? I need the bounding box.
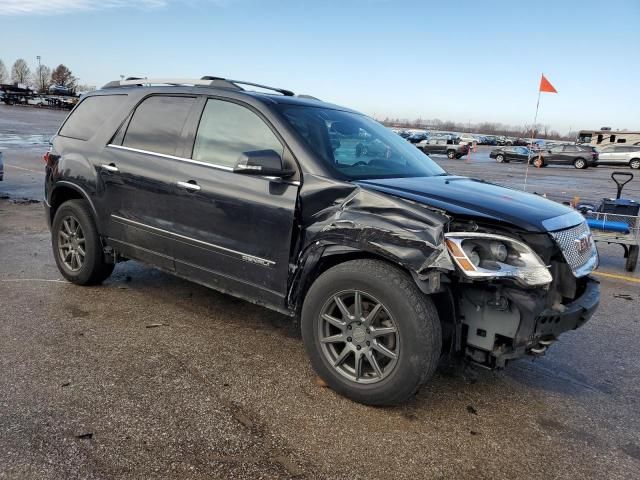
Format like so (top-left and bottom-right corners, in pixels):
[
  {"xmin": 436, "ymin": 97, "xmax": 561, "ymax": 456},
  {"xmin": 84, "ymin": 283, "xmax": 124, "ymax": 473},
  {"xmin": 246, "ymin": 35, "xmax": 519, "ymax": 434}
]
[{"xmin": 288, "ymin": 176, "xmax": 599, "ymax": 368}]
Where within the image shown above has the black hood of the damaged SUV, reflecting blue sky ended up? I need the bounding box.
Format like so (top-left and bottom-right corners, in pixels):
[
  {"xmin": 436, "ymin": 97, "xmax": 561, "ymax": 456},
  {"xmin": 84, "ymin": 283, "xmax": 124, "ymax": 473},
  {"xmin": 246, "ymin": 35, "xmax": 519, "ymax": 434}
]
[{"xmin": 357, "ymin": 176, "xmax": 574, "ymax": 232}]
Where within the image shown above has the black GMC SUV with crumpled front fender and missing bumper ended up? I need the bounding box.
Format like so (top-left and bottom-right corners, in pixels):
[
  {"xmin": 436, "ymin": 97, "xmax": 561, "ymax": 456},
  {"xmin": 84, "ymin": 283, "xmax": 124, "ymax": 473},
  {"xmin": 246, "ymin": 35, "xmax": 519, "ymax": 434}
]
[{"xmin": 45, "ymin": 77, "xmax": 599, "ymax": 405}]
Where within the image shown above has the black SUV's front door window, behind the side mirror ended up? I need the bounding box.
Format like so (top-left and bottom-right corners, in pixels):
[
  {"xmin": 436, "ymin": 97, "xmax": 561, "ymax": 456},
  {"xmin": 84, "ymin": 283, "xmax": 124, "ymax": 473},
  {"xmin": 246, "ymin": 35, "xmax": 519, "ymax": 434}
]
[{"xmin": 192, "ymin": 99, "xmax": 284, "ymax": 167}]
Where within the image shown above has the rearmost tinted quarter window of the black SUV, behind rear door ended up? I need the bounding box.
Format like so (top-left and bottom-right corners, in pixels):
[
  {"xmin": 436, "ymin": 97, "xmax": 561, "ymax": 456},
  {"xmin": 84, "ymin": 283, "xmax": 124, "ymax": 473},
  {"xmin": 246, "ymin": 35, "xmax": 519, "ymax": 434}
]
[{"xmin": 60, "ymin": 95, "xmax": 127, "ymax": 140}]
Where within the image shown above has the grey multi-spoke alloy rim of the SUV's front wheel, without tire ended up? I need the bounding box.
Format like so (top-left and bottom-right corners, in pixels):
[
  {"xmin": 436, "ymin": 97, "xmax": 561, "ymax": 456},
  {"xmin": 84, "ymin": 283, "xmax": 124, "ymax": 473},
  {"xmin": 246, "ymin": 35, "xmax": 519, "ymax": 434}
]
[{"xmin": 318, "ymin": 290, "xmax": 400, "ymax": 384}]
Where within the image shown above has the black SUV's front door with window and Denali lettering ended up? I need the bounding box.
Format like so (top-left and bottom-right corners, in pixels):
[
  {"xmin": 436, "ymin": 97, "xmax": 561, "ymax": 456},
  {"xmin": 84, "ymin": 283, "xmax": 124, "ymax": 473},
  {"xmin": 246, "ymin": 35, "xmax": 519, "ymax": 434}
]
[{"xmin": 172, "ymin": 98, "xmax": 299, "ymax": 307}]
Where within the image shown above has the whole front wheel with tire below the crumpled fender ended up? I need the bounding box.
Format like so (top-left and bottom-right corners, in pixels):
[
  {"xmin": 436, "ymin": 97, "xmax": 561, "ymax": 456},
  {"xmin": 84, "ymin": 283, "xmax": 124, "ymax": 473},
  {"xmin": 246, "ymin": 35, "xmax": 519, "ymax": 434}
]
[{"xmin": 302, "ymin": 260, "xmax": 442, "ymax": 406}]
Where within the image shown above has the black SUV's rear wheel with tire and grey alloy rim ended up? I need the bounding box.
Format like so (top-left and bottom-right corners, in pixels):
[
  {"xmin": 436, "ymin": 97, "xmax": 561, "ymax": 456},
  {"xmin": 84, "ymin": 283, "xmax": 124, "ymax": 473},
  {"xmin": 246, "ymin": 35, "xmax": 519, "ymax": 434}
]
[{"xmin": 51, "ymin": 200, "xmax": 114, "ymax": 285}]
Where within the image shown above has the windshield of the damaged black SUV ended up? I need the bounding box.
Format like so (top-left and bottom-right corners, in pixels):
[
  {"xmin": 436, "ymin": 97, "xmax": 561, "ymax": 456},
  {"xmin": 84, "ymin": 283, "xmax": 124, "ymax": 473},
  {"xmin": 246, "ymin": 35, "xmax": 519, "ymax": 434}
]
[{"xmin": 279, "ymin": 104, "xmax": 445, "ymax": 180}]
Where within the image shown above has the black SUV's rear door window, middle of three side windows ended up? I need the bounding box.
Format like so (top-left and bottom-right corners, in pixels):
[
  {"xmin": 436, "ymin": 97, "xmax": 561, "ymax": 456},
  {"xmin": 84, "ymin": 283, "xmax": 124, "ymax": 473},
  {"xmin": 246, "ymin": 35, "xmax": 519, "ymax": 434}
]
[{"xmin": 122, "ymin": 95, "xmax": 195, "ymax": 155}]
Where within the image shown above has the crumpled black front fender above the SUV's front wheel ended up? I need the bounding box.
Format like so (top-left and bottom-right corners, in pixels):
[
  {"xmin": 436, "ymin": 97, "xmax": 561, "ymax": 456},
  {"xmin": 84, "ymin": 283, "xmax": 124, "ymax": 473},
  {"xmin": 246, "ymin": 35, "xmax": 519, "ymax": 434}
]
[{"xmin": 288, "ymin": 175, "xmax": 455, "ymax": 309}]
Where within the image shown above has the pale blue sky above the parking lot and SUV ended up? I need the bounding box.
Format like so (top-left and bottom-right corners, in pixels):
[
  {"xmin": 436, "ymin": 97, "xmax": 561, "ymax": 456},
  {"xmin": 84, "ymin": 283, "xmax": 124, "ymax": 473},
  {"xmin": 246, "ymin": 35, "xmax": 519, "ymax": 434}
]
[{"xmin": 0, "ymin": 0, "xmax": 640, "ymax": 133}]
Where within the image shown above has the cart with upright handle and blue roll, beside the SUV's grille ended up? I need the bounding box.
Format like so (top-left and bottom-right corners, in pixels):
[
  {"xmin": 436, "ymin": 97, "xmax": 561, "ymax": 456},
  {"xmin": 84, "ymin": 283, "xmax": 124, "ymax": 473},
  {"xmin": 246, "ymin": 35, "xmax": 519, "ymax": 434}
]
[{"xmin": 583, "ymin": 172, "xmax": 640, "ymax": 272}]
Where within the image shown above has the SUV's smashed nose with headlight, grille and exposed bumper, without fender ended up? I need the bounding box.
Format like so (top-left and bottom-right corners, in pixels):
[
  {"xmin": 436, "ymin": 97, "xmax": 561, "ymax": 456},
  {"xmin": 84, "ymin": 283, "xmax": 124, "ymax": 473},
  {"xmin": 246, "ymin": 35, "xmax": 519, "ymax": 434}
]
[{"xmin": 447, "ymin": 224, "xmax": 600, "ymax": 368}]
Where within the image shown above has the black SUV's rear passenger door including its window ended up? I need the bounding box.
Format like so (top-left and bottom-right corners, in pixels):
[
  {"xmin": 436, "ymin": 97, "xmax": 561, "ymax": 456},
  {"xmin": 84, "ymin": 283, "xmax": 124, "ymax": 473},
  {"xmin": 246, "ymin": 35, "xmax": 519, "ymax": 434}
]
[{"xmin": 100, "ymin": 95, "xmax": 195, "ymax": 270}]
